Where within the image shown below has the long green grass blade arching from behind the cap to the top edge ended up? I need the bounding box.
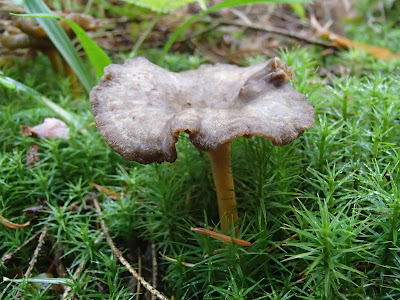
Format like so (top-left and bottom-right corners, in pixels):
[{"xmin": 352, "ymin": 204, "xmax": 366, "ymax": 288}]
[{"xmin": 159, "ymin": 0, "xmax": 310, "ymax": 64}]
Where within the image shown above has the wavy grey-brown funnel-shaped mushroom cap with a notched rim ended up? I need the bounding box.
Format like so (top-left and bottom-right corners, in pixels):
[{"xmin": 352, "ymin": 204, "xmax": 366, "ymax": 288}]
[{"xmin": 90, "ymin": 58, "xmax": 314, "ymax": 163}]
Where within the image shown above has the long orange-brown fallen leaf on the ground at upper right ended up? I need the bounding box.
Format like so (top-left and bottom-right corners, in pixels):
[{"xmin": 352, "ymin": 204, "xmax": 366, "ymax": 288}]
[{"xmin": 310, "ymin": 15, "xmax": 400, "ymax": 61}]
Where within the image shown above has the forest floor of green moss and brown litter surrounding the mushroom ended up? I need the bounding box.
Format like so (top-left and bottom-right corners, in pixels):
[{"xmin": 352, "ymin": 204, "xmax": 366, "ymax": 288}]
[{"xmin": 0, "ymin": 1, "xmax": 400, "ymax": 300}]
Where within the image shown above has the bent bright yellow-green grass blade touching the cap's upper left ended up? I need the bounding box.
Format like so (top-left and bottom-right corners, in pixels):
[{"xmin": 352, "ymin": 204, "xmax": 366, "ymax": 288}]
[{"xmin": 15, "ymin": 14, "xmax": 112, "ymax": 79}]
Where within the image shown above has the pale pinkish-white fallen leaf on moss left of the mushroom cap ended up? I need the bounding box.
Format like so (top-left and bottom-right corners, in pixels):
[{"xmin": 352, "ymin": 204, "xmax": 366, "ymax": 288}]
[{"xmin": 21, "ymin": 118, "xmax": 70, "ymax": 140}]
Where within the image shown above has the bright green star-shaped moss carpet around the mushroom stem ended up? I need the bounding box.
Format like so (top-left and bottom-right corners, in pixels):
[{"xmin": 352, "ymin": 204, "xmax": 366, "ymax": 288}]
[{"xmin": 0, "ymin": 10, "xmax": 400, "ymax": 299}]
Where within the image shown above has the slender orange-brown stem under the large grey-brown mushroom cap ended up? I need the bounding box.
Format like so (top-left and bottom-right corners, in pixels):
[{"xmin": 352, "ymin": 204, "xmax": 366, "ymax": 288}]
[{"xmin": 207, "ymin": 142, "xmax": 238, "ymax": 233}]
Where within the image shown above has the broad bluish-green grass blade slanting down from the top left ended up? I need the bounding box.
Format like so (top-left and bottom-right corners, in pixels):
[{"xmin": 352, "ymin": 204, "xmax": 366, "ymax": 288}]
[{"xmin": 24, "ymin": 0, "xmax": 93, "ymax": 92}]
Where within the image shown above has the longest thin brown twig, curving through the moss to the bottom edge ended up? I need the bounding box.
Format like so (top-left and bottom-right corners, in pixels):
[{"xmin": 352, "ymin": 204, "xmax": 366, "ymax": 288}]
[{"xmin": 93, "ymin": 198, "xmax": 168, "ymax": 300}]
